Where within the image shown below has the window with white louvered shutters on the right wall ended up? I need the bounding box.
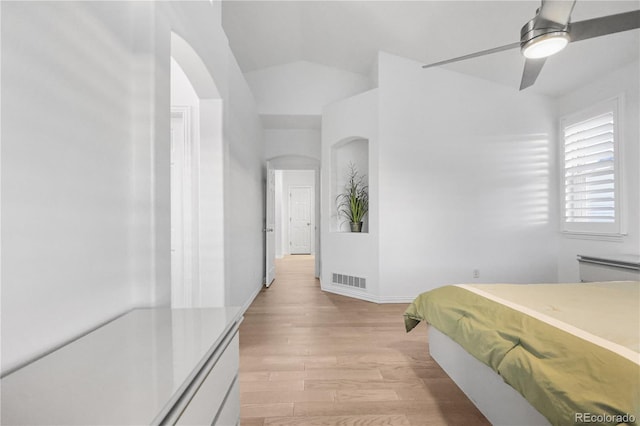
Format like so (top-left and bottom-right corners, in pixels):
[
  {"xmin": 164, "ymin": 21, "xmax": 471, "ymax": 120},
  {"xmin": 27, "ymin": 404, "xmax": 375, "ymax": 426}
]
[{"xmin": 560, "ymin": 98, "xmax": 621, "ymax": 234}]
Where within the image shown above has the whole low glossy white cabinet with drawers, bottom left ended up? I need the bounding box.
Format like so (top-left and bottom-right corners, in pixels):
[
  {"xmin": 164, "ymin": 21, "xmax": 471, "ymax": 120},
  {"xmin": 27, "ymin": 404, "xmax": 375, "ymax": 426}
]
[{"xmin": 1, "ymin": 308, "xmax": 242, "ymax": 426}]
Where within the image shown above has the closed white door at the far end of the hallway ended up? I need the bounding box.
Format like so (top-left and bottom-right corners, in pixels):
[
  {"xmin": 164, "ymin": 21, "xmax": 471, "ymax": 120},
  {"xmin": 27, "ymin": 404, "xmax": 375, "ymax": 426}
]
[{"xmin": 289, "ymin": 186, "xmax": 311, "ymax": 254}]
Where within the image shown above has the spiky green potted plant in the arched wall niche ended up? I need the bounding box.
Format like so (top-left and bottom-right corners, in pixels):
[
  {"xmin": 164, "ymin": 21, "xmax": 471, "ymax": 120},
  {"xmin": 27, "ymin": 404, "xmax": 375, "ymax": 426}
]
[{"xmin": 336, "ymin": 163, "xmax": 369, "ymax": 232}]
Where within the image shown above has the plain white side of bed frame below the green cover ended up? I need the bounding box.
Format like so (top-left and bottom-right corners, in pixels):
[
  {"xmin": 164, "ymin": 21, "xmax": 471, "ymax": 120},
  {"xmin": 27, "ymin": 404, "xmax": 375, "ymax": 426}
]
[{"xmin": 428, "ymin": 326, "xmax": 549, "ymax": 426}]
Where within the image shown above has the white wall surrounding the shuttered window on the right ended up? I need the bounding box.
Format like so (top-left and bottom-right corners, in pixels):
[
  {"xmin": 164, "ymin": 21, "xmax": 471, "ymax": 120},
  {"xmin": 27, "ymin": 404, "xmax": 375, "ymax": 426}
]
[{"xmin": 555, "ymin": 62, "xmax": 640, "ymax": 282}]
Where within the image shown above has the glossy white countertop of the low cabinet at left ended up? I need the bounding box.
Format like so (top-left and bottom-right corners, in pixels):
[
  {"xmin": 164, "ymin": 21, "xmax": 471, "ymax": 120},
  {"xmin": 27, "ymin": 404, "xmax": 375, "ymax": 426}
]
[{"xmin": 1, "ymin": 308, "xmax": 241, "ymax": 425}]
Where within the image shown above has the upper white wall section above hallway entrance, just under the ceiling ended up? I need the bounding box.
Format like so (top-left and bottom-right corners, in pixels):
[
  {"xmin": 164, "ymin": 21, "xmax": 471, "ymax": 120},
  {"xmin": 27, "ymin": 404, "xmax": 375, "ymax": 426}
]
[{"xmin": 245, "ymin": 61, "xmax": 372, "ymax": 115}]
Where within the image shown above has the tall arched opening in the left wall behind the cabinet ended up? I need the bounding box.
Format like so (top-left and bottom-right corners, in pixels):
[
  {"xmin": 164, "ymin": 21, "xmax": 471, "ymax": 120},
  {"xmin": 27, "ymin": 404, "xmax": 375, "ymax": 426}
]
[{"xmin": 171, "ymin": 32, "xmax": 226, "ymax": 308}]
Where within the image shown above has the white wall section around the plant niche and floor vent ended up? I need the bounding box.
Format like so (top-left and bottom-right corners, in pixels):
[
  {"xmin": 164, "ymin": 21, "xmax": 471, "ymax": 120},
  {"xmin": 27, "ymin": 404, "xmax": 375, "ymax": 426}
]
[{"xmin": 321, "ymin": 89, "xmax": 380, "ymax": 301}]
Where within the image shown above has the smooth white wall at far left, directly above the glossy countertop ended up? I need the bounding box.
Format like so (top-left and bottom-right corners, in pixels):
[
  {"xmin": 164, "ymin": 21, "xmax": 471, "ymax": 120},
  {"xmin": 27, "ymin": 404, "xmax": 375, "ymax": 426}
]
[{"xmin": 2, "ymin": 2, "xmax": 139, "ymax": 371}]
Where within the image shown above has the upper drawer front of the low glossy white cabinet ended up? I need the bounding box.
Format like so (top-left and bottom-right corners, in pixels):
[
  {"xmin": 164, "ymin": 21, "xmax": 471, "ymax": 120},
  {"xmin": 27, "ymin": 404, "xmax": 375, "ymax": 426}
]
[{"xmin": 176, "ymin": 333, "xmax": 240, "ymax": 425}]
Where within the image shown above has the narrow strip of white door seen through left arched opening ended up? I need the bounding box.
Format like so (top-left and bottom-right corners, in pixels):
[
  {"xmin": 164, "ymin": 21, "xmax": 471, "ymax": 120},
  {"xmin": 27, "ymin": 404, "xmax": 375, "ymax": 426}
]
[{"xmin": 170, "ymin": 107, "xmax": 192, "ymax": 308}]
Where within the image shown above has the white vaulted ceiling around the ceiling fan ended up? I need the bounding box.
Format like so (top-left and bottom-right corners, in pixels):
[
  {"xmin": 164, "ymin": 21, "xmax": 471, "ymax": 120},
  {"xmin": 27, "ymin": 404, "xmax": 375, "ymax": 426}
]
[{"xmin": 222, "ymin": 0, "xmax": 640, "ymax": 96}]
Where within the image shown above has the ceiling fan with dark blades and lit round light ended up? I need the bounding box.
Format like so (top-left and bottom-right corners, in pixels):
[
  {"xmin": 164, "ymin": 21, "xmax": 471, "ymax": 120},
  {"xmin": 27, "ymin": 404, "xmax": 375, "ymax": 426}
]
[{"xmin": 422, "ymin": 0, "xmax": 640, "ymax": 90}]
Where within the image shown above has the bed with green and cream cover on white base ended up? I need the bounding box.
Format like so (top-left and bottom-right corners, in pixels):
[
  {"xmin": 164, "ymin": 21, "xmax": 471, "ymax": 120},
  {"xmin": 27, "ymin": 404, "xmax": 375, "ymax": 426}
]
[{"xmin": 405, "ymin": 281, "xmax": 640, "ymax": 425}]
